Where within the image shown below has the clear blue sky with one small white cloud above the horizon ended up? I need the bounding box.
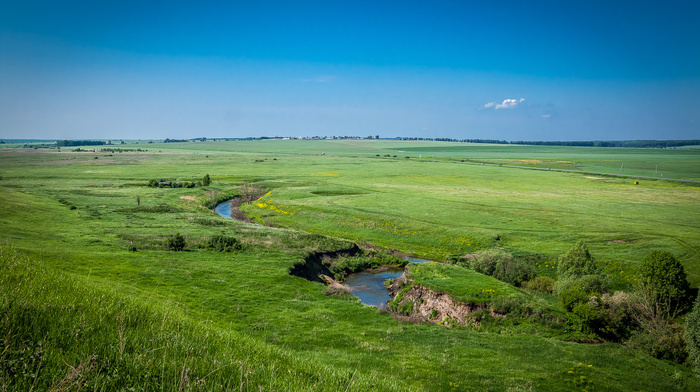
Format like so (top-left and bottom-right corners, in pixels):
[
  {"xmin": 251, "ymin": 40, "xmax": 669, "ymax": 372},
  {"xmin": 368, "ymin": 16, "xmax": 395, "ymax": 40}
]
[{"xmin": 0, "ymin": 0, "xmax": 700, "ymax": 140}]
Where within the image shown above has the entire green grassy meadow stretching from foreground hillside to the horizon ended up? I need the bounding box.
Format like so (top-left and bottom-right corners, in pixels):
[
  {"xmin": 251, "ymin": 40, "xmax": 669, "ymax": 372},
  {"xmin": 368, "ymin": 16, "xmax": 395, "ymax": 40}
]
[{"xmin": 0, "ymin": 140, "xmax": 700, "ymax": 391}]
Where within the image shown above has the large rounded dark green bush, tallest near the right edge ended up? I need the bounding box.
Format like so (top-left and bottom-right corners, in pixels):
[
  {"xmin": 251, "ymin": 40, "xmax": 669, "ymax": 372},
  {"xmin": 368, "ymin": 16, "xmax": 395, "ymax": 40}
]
[{"xmin": 638, "ymin": 250, "xmax": 690, "ymax": 315}]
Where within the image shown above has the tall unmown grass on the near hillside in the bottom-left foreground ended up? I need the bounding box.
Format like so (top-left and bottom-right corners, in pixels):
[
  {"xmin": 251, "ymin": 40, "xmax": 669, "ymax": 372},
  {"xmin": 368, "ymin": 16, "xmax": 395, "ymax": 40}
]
[{"xmin": 0, "ymin": 245, "xmax": 408, "ymax": 391}]
